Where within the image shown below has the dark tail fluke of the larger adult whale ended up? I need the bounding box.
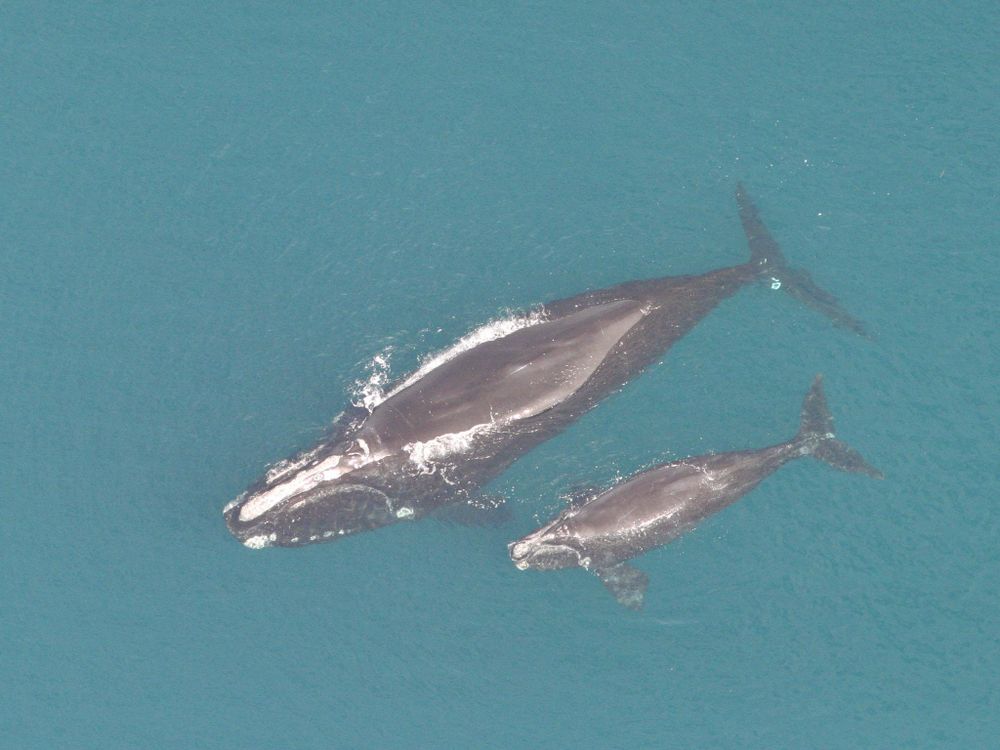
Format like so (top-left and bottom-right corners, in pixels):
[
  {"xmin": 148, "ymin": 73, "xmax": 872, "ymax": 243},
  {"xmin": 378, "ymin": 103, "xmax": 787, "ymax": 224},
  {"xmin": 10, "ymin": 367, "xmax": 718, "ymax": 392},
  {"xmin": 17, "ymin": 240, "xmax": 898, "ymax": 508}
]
[{"xmin": 736, "ymin": 183, "xmax": 868, "ymax": 337}]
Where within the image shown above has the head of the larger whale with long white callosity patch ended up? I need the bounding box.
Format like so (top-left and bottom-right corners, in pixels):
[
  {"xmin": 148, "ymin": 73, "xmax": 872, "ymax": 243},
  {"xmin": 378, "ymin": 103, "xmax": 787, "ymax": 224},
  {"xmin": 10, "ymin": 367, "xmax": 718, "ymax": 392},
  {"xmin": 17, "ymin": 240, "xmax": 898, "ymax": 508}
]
[{"xmin": 223, "ymin": 445, "xmax": 402, "ymax": 549}]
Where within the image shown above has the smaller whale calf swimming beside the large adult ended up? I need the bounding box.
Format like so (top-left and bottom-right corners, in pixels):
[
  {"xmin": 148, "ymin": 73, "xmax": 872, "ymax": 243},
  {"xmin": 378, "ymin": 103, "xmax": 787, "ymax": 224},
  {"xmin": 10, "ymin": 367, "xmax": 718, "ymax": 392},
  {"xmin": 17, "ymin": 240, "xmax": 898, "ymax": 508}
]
[{"xmin": 508, "ymin": 375, "xmax": 882, "ymax": 609}]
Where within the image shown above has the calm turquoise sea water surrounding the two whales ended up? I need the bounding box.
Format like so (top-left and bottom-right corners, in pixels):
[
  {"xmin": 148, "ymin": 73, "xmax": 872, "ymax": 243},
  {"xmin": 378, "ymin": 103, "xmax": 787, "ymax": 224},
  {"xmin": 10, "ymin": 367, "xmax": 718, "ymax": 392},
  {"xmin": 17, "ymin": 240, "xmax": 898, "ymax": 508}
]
[{"xmin": 0, "ymin": 2, "xmax": 1000, "ymax": 749}]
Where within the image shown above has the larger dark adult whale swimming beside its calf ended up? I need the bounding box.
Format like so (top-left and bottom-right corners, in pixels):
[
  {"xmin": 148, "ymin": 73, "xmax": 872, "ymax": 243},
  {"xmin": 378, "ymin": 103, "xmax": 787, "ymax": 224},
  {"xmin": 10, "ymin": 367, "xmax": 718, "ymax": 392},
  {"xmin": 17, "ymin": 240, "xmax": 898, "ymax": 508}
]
[{"xmin": 223, "ymin": 185, "xmax": 864, "ymax": 548}]
